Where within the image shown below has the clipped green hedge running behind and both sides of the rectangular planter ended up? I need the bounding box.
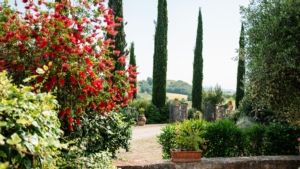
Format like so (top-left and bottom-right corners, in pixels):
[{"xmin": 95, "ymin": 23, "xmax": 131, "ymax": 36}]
[{"xmin": 158, "ymin": 120, "xmax": 300, "ymax": 158}]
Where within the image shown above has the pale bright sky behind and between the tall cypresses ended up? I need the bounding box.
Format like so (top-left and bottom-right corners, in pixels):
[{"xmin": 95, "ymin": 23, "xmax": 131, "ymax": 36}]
[{"xmin": 123, "ymin": 0, "xmax": 249, "ymax": 90}]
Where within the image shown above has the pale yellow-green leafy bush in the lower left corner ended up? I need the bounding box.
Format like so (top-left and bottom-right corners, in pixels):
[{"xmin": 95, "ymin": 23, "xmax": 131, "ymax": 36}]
[{"xmin": 0, "ymin": 72, "xmax": 62, "ymax": 168}]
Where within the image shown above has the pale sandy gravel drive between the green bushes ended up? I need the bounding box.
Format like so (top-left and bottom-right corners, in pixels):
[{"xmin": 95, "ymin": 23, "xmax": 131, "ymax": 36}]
[{"xmin": 113, "ymin": 124, "xmax": 164, "ymax": 166}]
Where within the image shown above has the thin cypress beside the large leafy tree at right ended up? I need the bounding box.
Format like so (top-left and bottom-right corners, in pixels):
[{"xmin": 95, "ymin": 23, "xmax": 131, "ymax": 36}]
[{"xmin": 235, "ymin": 24, "xmax": 246, "ymax": 108}]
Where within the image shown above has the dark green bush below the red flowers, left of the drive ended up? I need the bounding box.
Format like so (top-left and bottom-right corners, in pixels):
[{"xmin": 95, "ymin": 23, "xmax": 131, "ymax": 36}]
[{"xmin": 67, "ymin": 112, "xmax": 134, "ymax": 157}]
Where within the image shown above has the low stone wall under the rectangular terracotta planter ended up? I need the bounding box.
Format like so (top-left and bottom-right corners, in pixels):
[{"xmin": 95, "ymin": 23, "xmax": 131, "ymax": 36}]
[{"xmin": 117, "ymin": 156, "xmax": 300, "ymax": 169}]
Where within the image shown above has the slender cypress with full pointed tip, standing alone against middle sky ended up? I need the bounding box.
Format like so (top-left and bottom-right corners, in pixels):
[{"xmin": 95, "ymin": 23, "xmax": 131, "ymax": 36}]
[{"xmin": 192, "ymin": 8, "xmax": 203, "ymax": 110}]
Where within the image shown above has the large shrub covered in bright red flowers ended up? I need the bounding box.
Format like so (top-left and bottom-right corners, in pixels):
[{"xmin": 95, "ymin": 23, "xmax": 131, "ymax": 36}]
[{"xmin": 0, "ymin": 0, "xmax": 136, "ymax": 130}]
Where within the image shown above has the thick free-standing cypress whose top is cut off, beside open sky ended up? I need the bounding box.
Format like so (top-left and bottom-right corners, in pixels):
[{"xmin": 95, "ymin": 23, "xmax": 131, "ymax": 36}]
[{"xmin": 152, "ymin": 0, "xmax": 168, "ymax": 108}]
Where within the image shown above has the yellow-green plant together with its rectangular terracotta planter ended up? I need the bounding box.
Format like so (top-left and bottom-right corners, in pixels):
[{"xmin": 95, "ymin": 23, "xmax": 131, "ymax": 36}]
[{"xmin": 170, "ymin": 120, "xmax": 207, "ymax": 163}]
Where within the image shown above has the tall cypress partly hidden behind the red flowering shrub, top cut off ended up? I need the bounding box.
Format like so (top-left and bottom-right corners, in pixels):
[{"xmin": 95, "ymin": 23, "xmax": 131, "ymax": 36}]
[{"xmin": 107, "ymin": 0, "xmax": 128, "ymax": 70}]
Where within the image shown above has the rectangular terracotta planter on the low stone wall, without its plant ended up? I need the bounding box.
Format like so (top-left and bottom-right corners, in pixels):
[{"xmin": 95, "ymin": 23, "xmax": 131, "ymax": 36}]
[{"xmin": 170, "ymin": 150, "xmax": 202, "ymax": 163}]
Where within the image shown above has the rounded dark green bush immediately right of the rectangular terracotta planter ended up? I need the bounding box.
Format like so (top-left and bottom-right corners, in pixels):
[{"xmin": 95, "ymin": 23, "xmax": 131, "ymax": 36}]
[{"xmin": 203, "ymin": 119, "xmax": 244, "ymax": 157}]
